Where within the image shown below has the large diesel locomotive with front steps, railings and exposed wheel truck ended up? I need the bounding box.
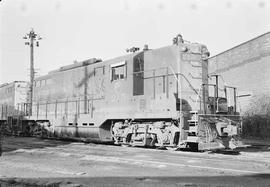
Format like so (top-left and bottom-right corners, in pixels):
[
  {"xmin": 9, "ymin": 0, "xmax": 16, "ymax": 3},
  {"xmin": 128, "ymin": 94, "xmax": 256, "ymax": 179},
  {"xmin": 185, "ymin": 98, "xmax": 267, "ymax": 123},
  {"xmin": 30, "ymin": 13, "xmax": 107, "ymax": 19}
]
[{"xmin": 6, "ymin": 35, "xmax": 241, "ymax": 150}]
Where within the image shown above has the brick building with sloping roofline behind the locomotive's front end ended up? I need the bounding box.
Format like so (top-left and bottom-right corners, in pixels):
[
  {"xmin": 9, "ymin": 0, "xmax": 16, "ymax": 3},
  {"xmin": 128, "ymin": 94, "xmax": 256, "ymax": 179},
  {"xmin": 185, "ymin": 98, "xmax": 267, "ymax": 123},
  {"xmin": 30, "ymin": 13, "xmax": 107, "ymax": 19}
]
[{"xmin": 209, "ymin": 32, "xmax": 270, "ymax": 138}]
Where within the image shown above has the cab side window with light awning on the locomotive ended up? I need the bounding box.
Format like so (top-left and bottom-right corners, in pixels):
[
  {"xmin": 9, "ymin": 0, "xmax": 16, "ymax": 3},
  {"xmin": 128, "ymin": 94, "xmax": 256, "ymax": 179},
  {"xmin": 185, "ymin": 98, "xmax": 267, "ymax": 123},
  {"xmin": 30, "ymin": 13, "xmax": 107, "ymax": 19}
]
[{"xmin": 111, "ymin": 62, "xmax": 127, "ymax": 81}]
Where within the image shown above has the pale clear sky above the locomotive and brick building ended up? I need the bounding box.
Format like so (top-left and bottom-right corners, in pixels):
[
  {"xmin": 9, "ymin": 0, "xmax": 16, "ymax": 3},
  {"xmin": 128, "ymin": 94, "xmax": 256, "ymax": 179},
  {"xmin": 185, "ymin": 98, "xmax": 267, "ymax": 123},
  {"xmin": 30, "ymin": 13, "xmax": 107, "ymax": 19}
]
[{"xmin": 0, "ymin": 0, "xmax": 270, "ymax": 84}]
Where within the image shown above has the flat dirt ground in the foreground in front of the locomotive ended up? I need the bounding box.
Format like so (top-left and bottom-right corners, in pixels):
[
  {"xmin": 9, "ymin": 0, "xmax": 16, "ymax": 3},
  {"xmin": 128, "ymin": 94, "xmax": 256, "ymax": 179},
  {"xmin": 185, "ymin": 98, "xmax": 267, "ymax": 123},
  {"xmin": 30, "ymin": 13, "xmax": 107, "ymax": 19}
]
[{"xmin": 0, "ymin": 137, "xmax": 270, "ymax": 187}]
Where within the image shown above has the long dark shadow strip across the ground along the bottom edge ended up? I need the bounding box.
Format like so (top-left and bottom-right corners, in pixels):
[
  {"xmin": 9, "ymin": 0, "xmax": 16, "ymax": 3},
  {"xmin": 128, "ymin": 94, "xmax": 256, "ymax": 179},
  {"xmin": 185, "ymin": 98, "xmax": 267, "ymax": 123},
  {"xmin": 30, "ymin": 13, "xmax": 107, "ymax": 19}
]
[{"xmin": 0, "ymin": 174, "xmax": 270, "ymax": 187}]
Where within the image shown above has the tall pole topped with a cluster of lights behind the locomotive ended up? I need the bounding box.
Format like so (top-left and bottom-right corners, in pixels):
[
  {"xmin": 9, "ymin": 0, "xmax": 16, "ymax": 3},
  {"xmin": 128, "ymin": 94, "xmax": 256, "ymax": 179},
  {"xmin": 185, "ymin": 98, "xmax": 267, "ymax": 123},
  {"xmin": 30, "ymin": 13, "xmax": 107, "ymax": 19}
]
[{"xmin": 23, "ymin": 29, "xmax": 42, "ymax": 115}]
